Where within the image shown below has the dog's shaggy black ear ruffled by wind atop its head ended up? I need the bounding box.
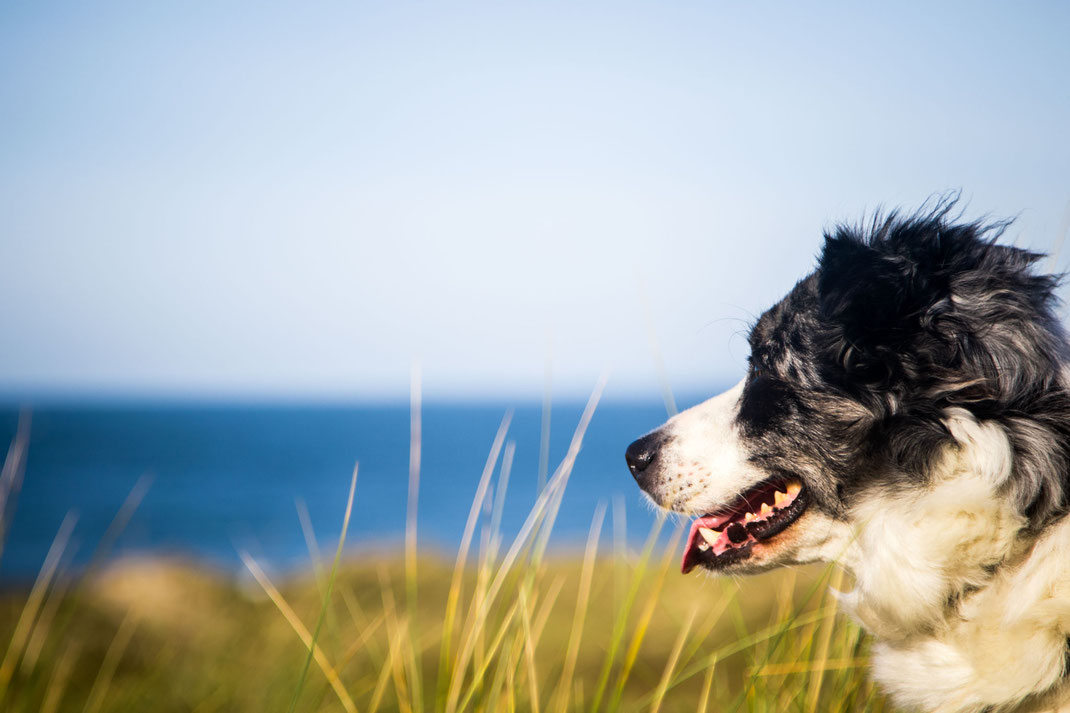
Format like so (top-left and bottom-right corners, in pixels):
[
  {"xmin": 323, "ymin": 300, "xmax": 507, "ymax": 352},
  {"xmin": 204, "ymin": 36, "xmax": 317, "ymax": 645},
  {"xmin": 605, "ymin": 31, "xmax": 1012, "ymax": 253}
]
[{"xmin": 817, "ymin": 204, "xmax": 1064, "ymax": 403}]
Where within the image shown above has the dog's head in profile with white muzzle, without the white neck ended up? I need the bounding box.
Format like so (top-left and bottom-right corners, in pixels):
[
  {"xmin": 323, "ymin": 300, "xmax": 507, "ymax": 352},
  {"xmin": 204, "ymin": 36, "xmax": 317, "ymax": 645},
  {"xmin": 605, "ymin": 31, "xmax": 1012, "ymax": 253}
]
[{"xmin": 627, "ymin": 196, "xmax": 1070, "ymax": 572}]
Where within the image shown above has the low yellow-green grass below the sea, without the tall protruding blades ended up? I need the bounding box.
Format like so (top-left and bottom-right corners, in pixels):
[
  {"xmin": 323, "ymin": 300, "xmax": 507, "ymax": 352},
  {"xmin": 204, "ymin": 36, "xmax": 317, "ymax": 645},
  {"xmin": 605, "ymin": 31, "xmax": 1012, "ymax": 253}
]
[{"xmin": 0, "ymin": 545, "xmax": 883, "ymax": 713}]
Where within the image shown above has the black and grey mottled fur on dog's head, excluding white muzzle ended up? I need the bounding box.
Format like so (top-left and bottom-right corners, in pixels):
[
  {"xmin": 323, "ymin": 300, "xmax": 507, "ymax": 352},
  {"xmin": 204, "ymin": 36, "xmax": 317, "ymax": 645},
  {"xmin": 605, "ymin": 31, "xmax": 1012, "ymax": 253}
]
[{"xmin": 738, "ymin": 198, "xmax": 1070, "ymax": 527}]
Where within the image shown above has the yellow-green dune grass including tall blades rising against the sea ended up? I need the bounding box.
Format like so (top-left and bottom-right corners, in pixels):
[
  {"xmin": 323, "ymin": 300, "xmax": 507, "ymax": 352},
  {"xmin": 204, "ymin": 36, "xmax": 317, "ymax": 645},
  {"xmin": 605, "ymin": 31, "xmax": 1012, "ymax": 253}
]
[{"xmin": 0, "ymin": 390, "xmax": 886, "ymax": 713}]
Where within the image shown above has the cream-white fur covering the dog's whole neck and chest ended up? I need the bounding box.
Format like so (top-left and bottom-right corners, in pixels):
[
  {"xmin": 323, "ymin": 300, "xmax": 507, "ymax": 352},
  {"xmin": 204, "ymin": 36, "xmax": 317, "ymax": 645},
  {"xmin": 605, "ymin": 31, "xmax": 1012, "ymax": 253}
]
[{"xmin": 841, "ymin": 418, "xmax": 1070, "ymax": 713}]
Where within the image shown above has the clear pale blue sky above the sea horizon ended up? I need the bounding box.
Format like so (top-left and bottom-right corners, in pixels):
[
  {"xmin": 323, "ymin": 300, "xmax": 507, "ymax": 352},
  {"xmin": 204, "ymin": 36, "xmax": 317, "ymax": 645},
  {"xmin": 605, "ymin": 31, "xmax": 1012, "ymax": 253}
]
[{"xmin": 0, "ymin": 1, "xmax": 1070, "ymax": 398}]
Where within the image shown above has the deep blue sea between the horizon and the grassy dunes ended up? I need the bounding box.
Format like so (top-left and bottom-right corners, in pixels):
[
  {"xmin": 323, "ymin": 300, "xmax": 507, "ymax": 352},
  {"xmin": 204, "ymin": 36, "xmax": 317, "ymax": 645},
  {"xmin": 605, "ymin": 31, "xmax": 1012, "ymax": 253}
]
[{"xmin": 0, "ymin": 399, "xmax": 710, "ymax": 582}]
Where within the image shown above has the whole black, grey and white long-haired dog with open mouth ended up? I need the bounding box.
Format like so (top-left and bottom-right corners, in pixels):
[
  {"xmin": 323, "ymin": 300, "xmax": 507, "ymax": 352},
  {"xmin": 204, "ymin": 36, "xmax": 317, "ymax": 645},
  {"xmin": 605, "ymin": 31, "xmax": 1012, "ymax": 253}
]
[{"xmin": 627, "ymin": 199, "xmax": 1070, "ymax": 713}]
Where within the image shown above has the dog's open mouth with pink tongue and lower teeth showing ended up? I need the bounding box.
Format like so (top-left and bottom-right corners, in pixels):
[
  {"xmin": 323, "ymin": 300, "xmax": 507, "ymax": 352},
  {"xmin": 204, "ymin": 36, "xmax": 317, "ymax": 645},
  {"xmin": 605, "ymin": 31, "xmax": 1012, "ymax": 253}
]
[{"xmin": 681, "ymin": 477, "xmax": 809, "ymax": 574}]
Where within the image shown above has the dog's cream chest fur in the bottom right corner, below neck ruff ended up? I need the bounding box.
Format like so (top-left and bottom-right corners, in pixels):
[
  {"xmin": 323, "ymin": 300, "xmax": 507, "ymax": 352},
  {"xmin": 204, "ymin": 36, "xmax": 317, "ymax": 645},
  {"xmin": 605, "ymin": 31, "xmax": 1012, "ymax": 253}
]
[{"xmin": 856, "ymin": 522, "xmax": 1070, "ymax": 713}]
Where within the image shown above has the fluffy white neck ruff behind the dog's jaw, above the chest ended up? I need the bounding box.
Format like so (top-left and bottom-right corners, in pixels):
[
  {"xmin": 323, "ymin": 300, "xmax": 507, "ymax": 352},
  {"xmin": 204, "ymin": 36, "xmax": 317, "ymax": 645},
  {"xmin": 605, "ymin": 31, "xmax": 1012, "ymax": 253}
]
[{"xmin": 842, "ymin": 416, "xmax": 1026, "ymax": 640}]
